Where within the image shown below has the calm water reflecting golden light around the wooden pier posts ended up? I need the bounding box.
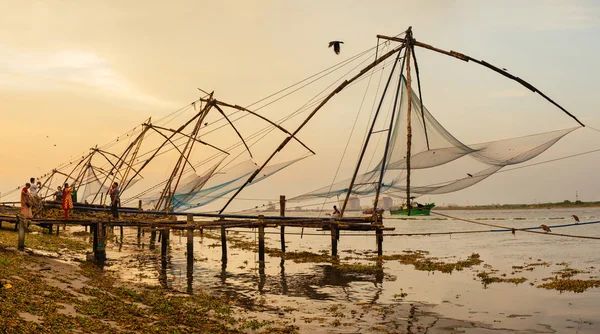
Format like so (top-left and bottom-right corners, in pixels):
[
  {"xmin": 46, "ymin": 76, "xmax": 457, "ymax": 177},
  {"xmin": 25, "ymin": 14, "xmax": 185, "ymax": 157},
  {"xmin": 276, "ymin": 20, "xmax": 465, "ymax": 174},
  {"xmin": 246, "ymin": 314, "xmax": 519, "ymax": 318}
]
[{"xmin": 107, "ymin": 208, "xmax": 600, "ymax": 333}]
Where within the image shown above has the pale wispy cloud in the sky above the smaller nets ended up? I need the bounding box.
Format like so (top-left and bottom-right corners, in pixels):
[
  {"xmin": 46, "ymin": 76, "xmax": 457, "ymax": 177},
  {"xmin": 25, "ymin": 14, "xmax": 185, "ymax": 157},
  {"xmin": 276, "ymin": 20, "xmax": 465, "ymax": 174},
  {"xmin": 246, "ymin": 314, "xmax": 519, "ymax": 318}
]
[{"xmin": 0, "ymin": 46, "xmax": 175, "ymax": 108}]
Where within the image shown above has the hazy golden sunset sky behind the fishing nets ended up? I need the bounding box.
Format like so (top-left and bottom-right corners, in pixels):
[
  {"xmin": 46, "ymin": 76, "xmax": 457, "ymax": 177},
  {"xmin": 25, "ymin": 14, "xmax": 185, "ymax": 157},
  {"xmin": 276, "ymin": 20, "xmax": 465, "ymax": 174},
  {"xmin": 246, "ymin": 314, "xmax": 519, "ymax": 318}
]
[{"xmin": 0, "ymin": 0, "xmax": 600, "ymax": 209}]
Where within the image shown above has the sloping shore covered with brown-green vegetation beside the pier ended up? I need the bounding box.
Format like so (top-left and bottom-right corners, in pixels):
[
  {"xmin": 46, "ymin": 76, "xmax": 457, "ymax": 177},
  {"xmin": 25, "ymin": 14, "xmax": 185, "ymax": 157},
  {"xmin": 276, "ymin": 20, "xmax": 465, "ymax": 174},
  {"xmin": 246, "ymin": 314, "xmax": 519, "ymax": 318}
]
[{"xmin": 0, "ymin": 226, "xmax": 298, "ymax": 333}]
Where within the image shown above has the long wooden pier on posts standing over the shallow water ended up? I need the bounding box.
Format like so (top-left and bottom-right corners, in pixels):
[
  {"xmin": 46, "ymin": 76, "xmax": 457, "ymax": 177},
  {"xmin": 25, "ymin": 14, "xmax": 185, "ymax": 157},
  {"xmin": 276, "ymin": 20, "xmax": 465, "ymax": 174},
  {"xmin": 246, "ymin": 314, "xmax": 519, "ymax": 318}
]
[{"xmin": 0, "ymin": 196, "xmax": 394, "ymax": 269}]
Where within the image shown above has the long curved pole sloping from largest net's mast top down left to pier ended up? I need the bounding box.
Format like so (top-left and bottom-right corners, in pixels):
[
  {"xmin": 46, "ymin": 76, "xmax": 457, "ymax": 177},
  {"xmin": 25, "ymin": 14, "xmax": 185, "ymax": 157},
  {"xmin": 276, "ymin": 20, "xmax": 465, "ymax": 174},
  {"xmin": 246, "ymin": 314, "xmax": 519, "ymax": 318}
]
[{"xmin": 219, "ymin": 46, "xmax": 403, "ymax": 213}]
